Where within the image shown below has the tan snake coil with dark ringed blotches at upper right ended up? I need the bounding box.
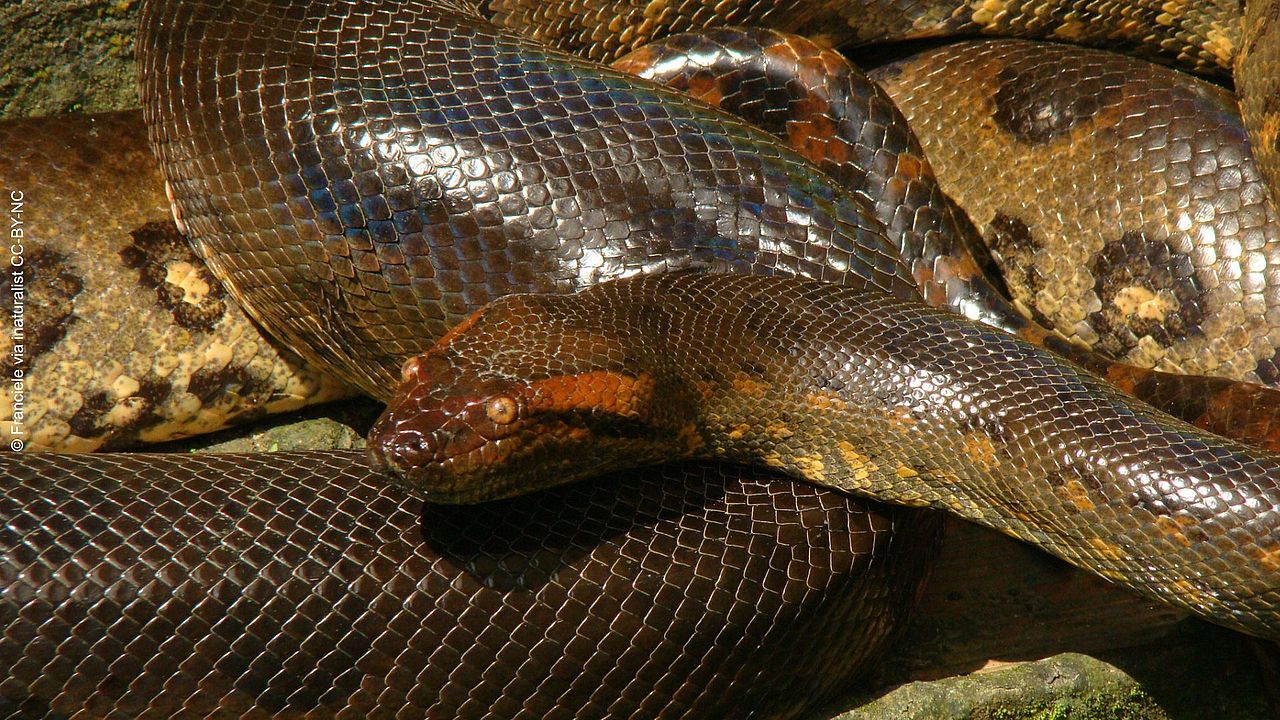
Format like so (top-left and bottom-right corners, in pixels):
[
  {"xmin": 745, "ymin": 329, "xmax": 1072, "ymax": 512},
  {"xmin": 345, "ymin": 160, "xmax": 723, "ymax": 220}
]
[{"xmin": 883, "ymin": 40, "xmax": 1280, "ymax": 382}]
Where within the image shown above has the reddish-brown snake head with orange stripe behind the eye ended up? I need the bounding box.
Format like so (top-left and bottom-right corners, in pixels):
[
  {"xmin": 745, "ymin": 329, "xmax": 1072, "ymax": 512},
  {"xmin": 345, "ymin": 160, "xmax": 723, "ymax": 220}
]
[{"xmin": 369, "ymin": 296, "xmax": 690, "ymax": 503}]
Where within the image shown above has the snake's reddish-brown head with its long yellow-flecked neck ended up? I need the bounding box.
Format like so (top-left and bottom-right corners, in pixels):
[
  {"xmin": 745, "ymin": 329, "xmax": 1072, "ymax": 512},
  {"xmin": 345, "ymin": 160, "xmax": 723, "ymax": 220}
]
[{"xmin": 370, "ymin": 273, "xmax": 1280, "ymax": 638}]
